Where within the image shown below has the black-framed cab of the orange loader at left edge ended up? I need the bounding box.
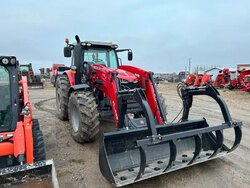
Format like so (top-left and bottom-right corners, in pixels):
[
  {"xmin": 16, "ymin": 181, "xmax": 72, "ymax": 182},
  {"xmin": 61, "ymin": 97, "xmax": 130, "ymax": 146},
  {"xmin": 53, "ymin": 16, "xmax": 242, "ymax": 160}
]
[{"xmin": 0, "ymin": 56, "xmax": 18, "ymax": 132}]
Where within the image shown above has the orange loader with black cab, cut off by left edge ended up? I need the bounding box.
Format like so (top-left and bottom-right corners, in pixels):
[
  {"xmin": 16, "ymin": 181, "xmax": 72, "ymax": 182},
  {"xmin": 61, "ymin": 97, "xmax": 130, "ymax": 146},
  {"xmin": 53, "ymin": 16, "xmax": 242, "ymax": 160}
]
[{"xmin": 0, "ymin": 56, "xmax": 58, "ymax": 188}]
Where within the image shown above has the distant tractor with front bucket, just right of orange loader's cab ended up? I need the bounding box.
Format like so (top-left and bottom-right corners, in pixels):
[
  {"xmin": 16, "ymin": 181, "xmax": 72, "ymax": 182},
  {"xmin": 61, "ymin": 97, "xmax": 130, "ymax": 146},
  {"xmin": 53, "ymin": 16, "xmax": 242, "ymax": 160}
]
[{"xmin": 19, "ymin": 63, "xmax": 43, "ymax": 89}]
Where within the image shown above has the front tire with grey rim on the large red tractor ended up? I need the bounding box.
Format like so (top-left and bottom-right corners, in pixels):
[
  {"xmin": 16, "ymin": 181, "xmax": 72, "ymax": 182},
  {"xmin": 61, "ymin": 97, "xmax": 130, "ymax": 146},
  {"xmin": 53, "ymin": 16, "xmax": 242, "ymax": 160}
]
[{"xmin": 68, "ymin": 91, "xmax": 100, "ymax": 143}]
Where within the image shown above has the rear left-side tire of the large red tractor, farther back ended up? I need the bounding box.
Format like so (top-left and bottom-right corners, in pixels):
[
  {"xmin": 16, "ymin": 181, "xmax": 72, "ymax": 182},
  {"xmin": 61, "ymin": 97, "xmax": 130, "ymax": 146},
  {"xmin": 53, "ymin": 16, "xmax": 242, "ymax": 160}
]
[{"xmin": 56, "ymin": 75, "xmax": 70, "ymax": 120}]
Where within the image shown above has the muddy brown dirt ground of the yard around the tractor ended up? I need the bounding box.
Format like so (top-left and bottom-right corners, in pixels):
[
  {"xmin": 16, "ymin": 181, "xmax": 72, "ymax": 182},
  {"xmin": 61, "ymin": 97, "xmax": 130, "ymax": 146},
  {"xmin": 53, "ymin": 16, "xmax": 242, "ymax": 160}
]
[{"xmin": 30, "ymin": 84, "xmax": 250, "ymax": 188}]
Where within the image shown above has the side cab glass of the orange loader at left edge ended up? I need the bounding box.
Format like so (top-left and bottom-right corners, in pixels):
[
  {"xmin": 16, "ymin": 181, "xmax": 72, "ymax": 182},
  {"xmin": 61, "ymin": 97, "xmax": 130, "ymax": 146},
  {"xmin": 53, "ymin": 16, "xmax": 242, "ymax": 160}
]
[{"xmin": 0, "ymin": 65, "xmax": 12, "ymax": 130}]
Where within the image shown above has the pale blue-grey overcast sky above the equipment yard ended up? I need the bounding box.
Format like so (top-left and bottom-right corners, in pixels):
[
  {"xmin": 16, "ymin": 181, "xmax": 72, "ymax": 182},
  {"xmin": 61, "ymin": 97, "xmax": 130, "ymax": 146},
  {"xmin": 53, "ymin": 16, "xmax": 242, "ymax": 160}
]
[{"xmin": 0, "ymin": 0, "xmax": 250, "ymax": 72}]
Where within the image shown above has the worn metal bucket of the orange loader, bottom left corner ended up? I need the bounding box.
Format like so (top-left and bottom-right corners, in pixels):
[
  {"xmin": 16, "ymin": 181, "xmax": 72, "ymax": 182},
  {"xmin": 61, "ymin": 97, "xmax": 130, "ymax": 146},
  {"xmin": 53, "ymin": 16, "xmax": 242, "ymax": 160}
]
[{"xmin": 0, "ymin": 160, "xmax": 59, "ymax": 188}]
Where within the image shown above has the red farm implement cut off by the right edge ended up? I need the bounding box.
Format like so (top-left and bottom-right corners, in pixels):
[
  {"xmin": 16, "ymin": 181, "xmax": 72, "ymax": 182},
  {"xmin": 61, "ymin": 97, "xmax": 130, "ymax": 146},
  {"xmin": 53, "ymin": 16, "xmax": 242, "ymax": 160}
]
[{"xmin": 229, "ymin": 69, "xmax": 250, "ymax": 92}]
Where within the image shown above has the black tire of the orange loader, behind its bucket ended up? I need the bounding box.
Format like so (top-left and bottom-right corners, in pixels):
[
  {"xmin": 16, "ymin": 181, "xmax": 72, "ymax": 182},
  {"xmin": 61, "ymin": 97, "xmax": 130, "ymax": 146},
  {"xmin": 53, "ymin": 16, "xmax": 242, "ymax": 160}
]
[{"xmin": 32, "ymin": 120, "xmax": 46, "ymax": 162}]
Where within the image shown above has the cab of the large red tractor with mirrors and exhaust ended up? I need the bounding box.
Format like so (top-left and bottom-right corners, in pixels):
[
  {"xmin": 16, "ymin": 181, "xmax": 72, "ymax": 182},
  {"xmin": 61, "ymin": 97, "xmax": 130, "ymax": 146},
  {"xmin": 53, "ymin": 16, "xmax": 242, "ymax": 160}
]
[{"xmin": 64, "ymin": 36, "xmax": 133, "ymax": 84}]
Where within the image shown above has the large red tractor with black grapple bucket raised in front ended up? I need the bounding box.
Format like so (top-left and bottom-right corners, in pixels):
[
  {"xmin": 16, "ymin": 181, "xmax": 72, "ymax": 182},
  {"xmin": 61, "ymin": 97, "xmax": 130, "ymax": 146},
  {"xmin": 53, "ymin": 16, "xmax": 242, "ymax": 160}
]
[{"xmin": 56, "ymin": 36, "xmax": 242, "ymax": 187}]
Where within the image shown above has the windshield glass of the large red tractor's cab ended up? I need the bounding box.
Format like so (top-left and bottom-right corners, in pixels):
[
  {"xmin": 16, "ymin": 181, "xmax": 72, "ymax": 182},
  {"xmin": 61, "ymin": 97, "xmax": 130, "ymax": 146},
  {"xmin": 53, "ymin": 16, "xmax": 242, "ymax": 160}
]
[{"xmin": 84, "ymin": 49, "xmax": 118, "ymax": 68}]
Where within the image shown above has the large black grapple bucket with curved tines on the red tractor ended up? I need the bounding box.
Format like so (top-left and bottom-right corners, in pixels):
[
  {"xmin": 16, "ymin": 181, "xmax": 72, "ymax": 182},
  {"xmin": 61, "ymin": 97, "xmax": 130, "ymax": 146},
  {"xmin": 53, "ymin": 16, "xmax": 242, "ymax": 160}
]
[{"xmin": 99, "ymin": 86, "xmax": 242, "ymax": 187}]
